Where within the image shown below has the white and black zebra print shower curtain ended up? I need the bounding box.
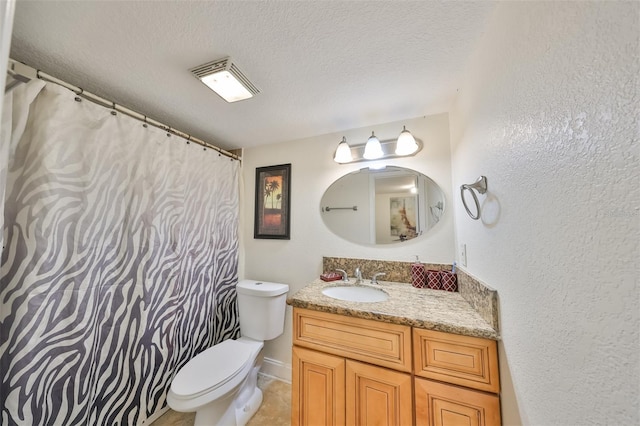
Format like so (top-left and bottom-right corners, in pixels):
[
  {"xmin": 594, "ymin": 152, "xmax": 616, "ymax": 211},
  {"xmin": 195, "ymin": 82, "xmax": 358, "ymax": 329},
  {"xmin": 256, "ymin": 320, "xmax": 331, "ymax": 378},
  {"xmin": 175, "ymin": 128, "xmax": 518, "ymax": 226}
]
[{"xmin": 0, "ymin": 81, "xmax": 239, "ymax": 425}]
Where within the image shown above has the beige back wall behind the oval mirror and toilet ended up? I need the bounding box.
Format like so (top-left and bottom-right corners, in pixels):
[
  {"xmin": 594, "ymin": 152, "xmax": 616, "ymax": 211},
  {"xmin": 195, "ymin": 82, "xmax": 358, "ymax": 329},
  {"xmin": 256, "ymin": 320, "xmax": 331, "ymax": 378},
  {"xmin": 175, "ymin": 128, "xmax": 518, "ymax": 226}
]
[{"xmin": 240, "ymin": 114, "xmax": 454, "ymax": 378}]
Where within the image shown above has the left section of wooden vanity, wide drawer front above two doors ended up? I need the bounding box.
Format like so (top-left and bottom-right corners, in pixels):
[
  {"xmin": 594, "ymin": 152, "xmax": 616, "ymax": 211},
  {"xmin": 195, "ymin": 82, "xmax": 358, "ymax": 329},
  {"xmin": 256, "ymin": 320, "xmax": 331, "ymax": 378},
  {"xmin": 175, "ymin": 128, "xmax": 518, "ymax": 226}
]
[{"xmin": 291, "ymin": 308, "xmax": 413, "ymax": 426}]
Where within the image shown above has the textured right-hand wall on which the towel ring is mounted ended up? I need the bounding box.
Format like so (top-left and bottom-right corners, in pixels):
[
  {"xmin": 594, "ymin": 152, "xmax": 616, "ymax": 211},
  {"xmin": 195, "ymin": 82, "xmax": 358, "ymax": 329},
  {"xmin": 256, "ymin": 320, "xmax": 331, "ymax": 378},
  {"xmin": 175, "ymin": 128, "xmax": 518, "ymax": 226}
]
[{"xmin": 450, "ymin": 2, "xmax": 640, "ymax": 425}]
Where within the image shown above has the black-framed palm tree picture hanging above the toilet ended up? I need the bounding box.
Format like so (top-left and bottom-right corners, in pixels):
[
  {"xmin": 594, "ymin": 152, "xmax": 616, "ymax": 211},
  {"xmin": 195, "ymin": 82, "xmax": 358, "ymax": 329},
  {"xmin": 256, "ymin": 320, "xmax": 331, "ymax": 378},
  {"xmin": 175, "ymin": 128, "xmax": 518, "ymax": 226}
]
[{"xmin": 253, "ymin": 163, "xmax": 291, "ymax": 240}]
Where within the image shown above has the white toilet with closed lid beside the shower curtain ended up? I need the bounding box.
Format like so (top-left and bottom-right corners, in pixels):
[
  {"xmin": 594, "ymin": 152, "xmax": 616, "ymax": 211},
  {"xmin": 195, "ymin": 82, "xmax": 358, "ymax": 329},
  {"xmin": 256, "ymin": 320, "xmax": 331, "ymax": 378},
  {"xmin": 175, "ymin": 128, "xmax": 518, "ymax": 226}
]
[{"xmin": 167, "ymin": 280, "xmax": 289, "ymax": 426}]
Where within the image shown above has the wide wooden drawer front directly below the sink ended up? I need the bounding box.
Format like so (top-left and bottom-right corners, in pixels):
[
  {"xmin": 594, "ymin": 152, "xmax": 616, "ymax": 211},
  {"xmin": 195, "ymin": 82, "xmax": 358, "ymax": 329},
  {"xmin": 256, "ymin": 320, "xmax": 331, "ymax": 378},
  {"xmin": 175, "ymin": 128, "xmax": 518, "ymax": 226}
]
[{"xmin": 293, "ymin": 308, "xmax": 411, "ymax": 372}]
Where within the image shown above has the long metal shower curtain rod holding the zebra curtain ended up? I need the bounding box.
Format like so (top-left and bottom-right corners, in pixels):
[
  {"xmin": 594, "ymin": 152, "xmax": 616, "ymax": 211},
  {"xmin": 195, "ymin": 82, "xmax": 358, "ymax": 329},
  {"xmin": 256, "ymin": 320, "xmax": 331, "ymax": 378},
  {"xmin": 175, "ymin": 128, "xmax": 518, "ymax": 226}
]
[{"xmin": 5, "ymin": 58, "xmax": 241, "ymax": 161}]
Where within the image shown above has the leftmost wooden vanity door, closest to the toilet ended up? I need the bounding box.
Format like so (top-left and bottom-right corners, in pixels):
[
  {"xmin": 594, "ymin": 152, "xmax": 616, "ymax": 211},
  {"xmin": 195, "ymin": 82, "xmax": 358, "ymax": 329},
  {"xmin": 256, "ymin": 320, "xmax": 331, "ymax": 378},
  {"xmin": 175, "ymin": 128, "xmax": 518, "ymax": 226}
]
[{"xmin": 291, "ymin": 346, "xmax": 345, "ymax": 426}]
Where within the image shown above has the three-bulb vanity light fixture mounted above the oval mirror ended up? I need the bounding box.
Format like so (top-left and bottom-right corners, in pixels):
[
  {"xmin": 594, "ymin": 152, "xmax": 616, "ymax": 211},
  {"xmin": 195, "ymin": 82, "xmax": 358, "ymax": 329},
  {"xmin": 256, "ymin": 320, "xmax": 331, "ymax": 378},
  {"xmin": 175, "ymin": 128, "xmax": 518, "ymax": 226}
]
[{"xmin": 333, "ymin": 126, "xmax": 422, "ymax": 164}]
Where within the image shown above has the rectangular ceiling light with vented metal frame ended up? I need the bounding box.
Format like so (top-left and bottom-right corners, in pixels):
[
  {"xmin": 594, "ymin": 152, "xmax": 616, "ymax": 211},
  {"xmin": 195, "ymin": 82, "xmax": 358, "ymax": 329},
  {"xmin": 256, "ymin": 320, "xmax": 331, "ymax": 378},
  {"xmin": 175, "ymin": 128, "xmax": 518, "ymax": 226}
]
[{"xmin": 189, "ymin": 57, "xmax": 260, "ymax": 102}]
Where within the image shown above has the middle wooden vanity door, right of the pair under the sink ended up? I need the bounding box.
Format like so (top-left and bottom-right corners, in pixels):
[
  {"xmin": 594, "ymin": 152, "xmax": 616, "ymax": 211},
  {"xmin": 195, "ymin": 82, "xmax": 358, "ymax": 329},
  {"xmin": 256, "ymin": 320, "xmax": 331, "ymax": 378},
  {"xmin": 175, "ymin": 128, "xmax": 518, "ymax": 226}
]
[{"xmin": 346, "ymin": 360, "xmax": 413, "ymax": 426}]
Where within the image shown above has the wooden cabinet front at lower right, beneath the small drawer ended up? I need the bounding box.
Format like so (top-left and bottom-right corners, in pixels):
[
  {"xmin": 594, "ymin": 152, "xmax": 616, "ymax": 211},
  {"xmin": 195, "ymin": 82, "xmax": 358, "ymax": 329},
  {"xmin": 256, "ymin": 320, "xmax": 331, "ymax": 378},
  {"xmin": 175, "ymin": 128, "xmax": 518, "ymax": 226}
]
[{"xmin": 415, "ymin": 378, "xmax": 501, "ymax": 426}]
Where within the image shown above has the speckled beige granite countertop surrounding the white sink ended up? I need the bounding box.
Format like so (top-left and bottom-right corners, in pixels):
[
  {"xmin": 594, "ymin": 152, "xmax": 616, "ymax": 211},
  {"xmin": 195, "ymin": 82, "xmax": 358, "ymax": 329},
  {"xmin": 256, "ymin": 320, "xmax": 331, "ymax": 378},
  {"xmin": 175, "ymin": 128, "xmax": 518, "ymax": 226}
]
[{"xmin": 287, "ymin": 279, "xmax": 500, "ymax": 340}]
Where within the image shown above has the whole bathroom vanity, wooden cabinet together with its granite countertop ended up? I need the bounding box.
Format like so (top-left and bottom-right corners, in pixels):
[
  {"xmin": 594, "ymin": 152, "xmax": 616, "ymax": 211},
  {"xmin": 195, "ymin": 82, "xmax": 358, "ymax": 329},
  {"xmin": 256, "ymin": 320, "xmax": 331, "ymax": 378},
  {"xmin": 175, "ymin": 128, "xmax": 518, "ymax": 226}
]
[{"xmin": 287, "ymin": 280, "xmax": 500, "ymax": 426}]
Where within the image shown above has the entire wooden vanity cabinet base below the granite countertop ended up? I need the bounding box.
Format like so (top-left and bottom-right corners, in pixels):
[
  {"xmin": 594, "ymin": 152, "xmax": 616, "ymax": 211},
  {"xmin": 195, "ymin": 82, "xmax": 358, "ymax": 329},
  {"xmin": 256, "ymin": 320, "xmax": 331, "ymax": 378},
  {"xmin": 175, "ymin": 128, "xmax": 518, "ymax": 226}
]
[{"xmin": 291, "ymin": 307, "xmax": 501, "ymax": 426}]
